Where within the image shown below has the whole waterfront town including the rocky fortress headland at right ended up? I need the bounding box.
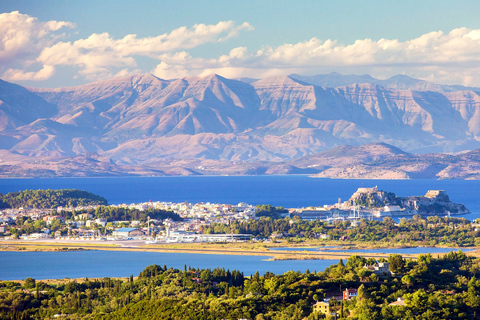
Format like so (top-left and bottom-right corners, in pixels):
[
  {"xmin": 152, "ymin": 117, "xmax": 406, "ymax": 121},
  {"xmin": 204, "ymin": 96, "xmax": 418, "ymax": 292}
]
[{"xmin": 0, "ymin": 187, "xmax": 477, "ymax": 244}]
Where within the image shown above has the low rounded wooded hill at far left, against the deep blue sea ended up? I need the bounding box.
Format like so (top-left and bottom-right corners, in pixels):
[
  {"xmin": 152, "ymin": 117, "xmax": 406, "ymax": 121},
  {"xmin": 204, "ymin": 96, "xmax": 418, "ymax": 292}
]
[{"xmin": 0, "ymin": 189, "xmax": 108, "ymax": 209}]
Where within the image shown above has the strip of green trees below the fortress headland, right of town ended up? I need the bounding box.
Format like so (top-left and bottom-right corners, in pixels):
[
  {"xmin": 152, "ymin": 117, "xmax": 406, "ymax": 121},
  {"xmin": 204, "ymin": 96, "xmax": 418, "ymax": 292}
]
[{"xmin": 204, "ymin": 215, "xmax": 480, "ymax": 247}]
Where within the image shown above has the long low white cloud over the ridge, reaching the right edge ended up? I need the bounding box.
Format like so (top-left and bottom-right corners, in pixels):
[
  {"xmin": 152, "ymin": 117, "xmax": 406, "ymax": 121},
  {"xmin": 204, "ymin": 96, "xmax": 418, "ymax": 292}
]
[{"xmin": 150, "ymin": 28, "xmax": 480, "ymax": 86}]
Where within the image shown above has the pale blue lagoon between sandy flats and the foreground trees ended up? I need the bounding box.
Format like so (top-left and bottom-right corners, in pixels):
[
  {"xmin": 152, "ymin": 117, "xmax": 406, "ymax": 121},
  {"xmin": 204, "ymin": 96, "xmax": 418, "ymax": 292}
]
[{"xmin": 0, "ymin": 250, "xmax": 338, "ymax": 280}]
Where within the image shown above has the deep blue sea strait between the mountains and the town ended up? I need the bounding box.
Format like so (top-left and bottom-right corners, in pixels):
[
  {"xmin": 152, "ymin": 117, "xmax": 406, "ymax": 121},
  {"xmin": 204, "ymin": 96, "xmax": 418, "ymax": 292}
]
[{"xmin": 0, "ymin": 175, "xmax": 480, "ymax": 220}]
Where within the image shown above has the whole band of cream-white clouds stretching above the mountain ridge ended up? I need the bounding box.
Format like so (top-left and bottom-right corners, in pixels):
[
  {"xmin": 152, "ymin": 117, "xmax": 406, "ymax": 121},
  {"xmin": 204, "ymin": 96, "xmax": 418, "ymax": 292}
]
[{"xmin": 0, "ymin": 11, "xmax": 480, "ymax": 86}]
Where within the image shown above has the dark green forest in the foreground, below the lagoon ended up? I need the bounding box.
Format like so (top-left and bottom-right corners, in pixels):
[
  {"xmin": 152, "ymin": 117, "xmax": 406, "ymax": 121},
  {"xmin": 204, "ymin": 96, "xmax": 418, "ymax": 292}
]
[{"xmin": 0, "ymin": 251, "xmax": 480, "ymax": 320}]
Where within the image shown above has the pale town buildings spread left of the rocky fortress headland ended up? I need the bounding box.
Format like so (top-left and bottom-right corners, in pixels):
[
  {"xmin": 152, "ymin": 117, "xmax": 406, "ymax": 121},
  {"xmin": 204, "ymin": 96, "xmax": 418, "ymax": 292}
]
[{"xmin": 0, "ymin": 201, "xmax": 256, "ymax": 242}]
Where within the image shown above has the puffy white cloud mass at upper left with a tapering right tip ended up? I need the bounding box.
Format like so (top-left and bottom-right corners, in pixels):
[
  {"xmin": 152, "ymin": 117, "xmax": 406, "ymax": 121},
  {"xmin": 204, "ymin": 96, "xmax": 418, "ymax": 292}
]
[{"xmin": 0, "ymin": 11, "xmax": 253, "ymax": 81}]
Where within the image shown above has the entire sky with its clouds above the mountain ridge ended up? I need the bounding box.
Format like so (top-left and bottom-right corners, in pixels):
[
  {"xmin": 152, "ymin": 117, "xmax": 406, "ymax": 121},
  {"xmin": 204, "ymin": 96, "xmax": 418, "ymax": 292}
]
[{"xmin": 0, "ymin": 0, "xmax": 480, "ymax": 87}]
